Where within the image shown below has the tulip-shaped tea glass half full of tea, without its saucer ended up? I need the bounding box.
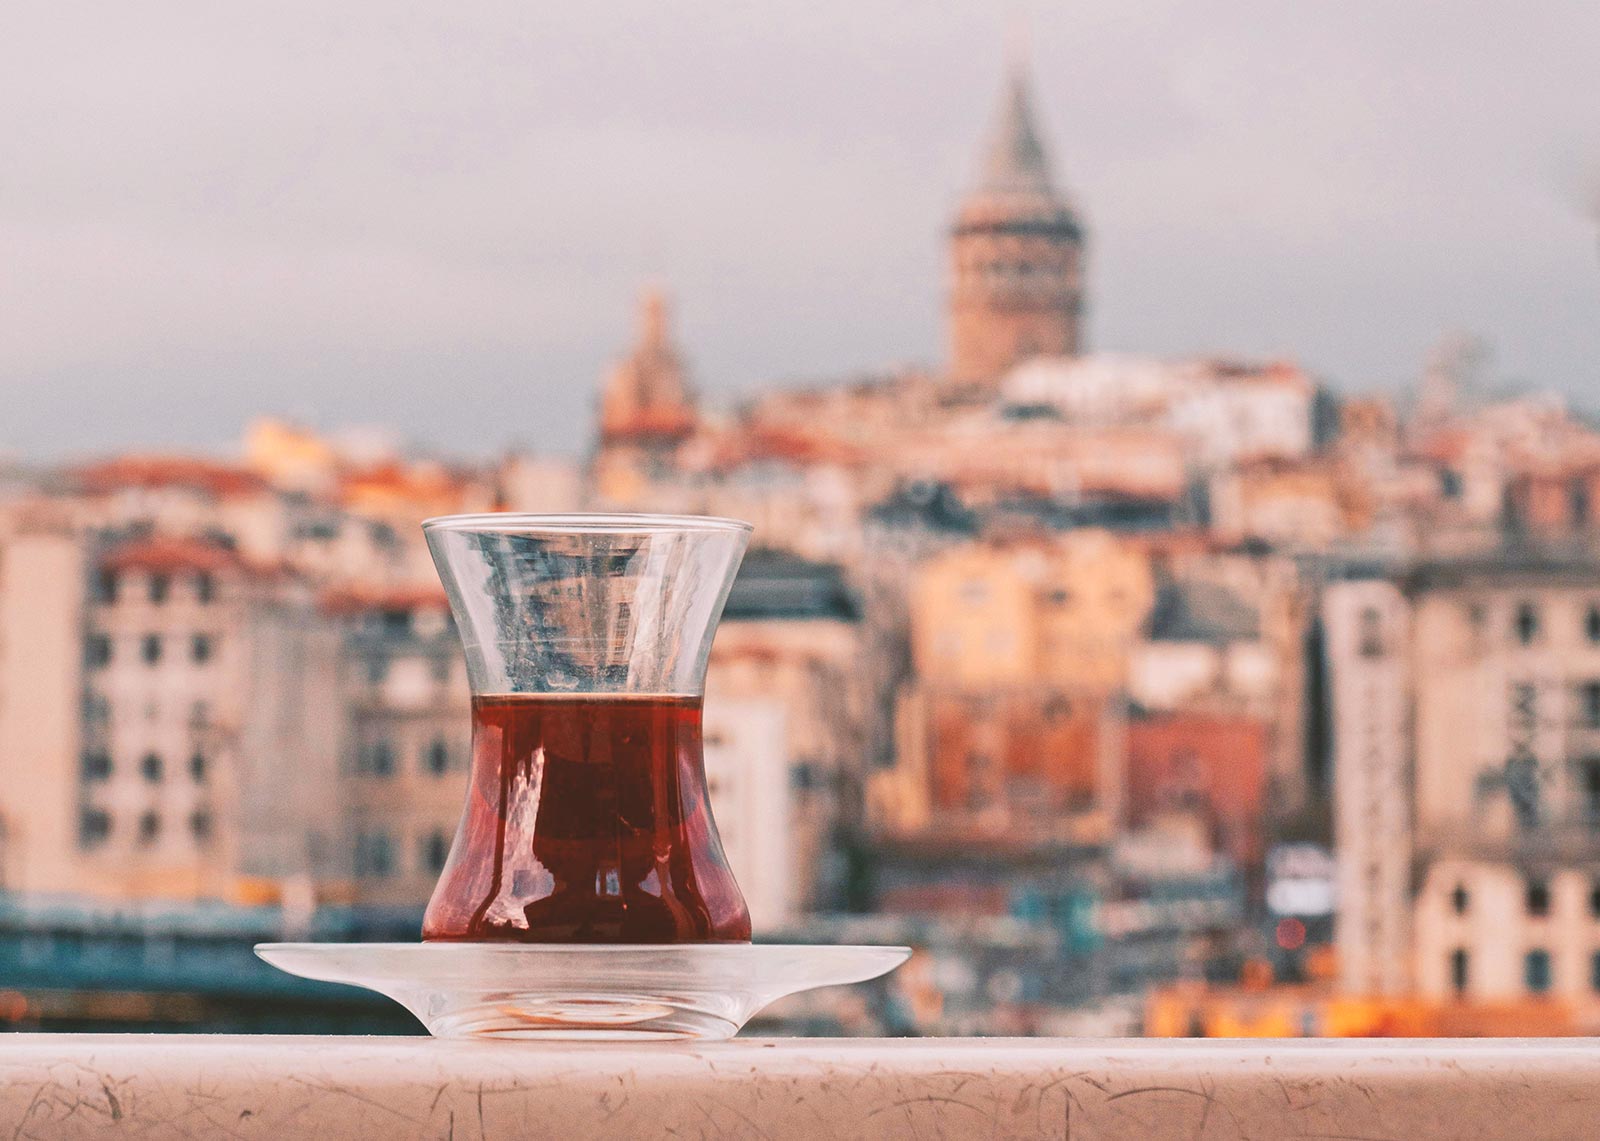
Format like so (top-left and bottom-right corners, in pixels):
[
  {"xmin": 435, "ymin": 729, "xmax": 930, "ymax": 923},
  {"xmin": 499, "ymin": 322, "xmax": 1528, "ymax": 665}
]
[{"xmin": 422, "ymin": 515, "xmax": 750, "ymax": 943}]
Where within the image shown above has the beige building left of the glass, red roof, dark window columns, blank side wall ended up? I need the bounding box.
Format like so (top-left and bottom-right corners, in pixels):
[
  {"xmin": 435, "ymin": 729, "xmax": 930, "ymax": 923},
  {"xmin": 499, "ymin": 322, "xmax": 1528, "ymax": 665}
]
[{"xmin": 74, "ymin": 538, "xmax": 339, "ymax": 903}]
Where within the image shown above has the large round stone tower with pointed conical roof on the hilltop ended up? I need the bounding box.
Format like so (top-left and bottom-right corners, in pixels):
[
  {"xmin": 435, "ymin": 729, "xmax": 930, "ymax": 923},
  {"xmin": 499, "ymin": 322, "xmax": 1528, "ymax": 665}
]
[{"xmin": 950, "ymin": 58, "xmax": 1083, "ymax": 386}]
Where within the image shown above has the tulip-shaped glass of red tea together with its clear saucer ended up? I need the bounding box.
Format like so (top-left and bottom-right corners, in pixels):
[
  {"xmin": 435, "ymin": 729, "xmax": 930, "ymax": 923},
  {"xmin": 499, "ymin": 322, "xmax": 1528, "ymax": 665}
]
[{"xmin": 256, "ymin": 514, "xmax": 910, "ymax": 1039}]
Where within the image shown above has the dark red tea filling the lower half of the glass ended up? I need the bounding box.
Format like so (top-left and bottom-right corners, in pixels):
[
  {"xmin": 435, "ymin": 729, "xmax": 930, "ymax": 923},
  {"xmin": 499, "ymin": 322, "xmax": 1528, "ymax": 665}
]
[{"xmin": 422, "ymin": 695, "xmax": 750, "ymax": 943}]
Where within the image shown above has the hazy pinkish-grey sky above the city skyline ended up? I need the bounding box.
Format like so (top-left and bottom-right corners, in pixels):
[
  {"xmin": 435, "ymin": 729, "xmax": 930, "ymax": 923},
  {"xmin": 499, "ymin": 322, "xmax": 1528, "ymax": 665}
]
[{"xmin": 0, "ymin": 0, "xmax": 1600, "ymax": 456}]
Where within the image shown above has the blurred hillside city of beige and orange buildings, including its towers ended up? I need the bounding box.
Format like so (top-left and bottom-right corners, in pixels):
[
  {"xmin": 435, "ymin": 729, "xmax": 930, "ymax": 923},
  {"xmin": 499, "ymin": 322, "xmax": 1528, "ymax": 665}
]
[{"xmin": 0, "ymin": 62, "xmax": 1600, "ymax": 1035}]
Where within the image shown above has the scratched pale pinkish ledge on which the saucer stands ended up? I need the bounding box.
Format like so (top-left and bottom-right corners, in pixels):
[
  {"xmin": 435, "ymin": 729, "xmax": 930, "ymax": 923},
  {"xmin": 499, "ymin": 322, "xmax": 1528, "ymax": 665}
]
[{"xmin": 0, "ymin": 1034, "xmax": 1600, "ymax": 1141}]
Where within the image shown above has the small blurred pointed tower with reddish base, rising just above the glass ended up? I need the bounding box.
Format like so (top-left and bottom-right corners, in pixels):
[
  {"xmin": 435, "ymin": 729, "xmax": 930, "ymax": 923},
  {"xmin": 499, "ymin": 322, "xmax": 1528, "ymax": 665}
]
[{"xmin": 592, "ymin": 290, "xmax": 698, "ymax": 502}]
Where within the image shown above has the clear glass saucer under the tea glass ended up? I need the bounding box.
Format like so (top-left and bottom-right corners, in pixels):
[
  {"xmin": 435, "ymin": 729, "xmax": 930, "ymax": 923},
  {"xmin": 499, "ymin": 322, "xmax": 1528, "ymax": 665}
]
[{"xmin": 256, "ymin": 943, "xmax": 910, "ymax": 1040}]
